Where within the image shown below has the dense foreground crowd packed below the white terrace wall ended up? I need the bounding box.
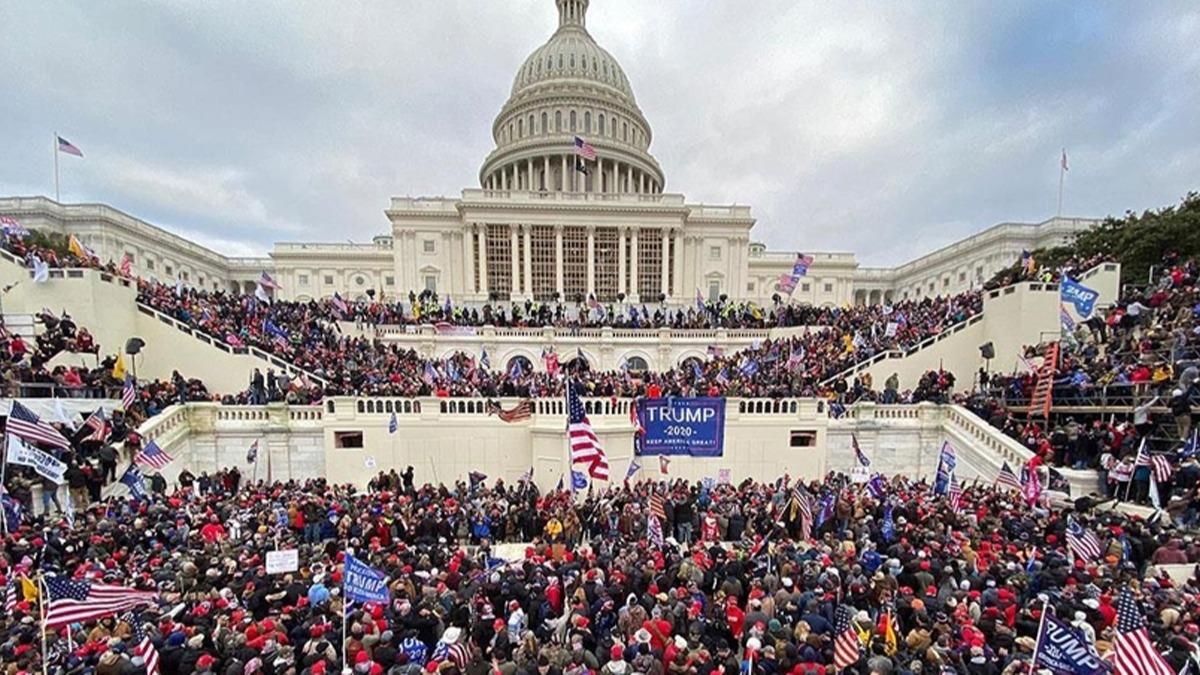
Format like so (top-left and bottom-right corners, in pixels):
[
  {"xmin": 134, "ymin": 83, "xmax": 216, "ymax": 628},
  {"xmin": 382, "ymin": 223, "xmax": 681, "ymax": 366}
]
[{"xmin": 0, "ymin": 468, "xmax": 1200, "ymax": 675}]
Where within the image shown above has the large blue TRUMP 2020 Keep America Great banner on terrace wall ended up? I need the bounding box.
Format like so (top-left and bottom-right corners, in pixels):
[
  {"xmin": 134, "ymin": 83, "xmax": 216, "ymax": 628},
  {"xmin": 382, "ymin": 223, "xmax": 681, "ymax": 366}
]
[{"xmin": 637, "ymin": 398, "xmax": 725, "ymax": 458}]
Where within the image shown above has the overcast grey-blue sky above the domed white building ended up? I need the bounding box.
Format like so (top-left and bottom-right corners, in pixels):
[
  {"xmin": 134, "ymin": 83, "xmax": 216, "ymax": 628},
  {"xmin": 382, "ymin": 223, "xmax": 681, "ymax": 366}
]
[{"xmin": 0, "ymin": 0, "xmax": 1200, "ymax": 264}]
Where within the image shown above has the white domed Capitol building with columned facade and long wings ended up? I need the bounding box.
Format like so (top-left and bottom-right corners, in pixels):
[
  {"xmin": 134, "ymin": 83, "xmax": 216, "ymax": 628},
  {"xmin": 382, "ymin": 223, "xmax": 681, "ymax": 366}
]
[{"xmin": 0, "ymin": 0, "xmax": 1097, "ymax": 305}]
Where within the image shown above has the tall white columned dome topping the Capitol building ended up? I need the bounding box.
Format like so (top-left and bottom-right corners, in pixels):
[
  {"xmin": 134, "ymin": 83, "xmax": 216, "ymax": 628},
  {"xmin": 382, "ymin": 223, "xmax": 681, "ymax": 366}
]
[{"xmin": 479, "ymin": 0, "xmax": 664, "ymax": 193}]
